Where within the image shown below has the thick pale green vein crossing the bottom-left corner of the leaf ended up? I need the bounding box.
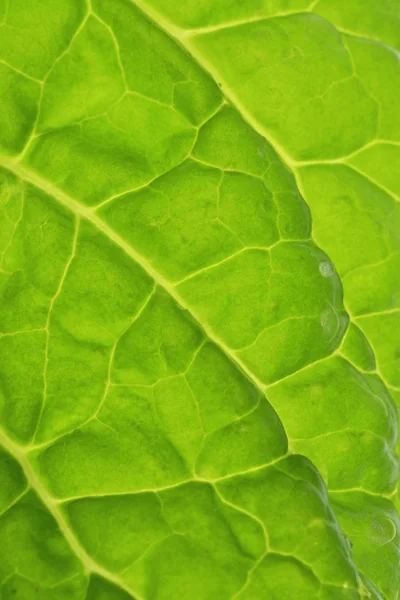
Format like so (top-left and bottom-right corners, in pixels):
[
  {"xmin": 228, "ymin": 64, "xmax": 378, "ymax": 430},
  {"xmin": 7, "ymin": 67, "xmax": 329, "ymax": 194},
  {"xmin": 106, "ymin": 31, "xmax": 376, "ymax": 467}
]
[{"xmin": 0, "ymin": 431, "xmax": 140, "ymax": 600}]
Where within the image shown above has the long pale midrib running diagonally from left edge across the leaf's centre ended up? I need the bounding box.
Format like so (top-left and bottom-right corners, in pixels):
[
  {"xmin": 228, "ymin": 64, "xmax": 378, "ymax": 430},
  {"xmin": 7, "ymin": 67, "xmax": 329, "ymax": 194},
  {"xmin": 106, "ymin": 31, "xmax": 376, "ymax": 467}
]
[{"xmin": 0, "ymin": 156, "xmax": 268, "ymax": 395}]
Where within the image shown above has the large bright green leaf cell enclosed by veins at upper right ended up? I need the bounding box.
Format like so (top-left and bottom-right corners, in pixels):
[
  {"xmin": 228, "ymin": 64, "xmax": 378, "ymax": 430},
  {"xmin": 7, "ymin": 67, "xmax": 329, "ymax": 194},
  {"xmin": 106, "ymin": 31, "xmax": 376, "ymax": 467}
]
[{"xmin": 190, "ymin": 14, "xmax": 379, "ymax": 160}]
